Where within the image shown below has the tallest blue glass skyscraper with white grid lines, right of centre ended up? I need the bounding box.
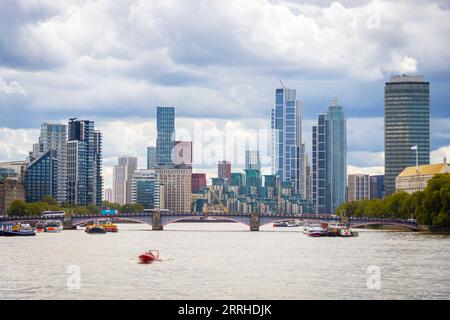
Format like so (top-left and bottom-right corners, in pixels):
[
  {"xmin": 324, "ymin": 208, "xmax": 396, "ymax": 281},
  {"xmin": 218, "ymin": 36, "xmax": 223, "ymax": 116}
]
[{"xmin": 271, "ymin": 88, "xmax": 305, "ymax": 195}]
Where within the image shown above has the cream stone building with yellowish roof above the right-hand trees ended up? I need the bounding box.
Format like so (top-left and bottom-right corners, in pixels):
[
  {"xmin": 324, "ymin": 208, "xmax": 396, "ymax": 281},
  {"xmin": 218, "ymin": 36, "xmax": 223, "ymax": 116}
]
[{"xmin": 395, "ymin": 163, "xmax": 450, "ymax": 194}]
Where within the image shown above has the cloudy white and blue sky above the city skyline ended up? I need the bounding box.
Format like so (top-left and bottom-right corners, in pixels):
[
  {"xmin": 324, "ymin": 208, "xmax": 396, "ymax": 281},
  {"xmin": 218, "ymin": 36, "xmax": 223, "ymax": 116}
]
[{"xmin": 0, "ymin": 0, "xmax": 450, "ymax": 186}]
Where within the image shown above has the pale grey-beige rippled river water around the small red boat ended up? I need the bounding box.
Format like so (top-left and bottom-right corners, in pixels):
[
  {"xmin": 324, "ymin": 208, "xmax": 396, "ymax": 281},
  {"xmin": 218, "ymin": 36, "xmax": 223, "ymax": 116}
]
[{"xmin": 0, "ymin": 223, "xmax": 450, "ymax": 299}]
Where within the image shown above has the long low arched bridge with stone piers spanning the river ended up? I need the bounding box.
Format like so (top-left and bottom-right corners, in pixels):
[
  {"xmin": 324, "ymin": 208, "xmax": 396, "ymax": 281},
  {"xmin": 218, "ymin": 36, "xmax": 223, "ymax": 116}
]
[{"xmin": 0, "ymin": 210, "xmax": 419, "ymax": 231}]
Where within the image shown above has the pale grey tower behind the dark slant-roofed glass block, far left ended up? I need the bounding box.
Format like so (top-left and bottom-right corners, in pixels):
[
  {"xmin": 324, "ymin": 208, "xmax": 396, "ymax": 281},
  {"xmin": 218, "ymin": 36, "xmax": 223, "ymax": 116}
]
[{"xmin": 30, "ymin": 123, "xmax": 67, "ymax": 203}]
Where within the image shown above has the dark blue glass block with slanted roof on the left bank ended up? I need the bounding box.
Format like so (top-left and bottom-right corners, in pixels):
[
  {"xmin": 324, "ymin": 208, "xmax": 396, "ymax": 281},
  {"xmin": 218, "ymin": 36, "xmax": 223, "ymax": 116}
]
[{"xmin": 25, "ymin": 150, "xmax": 59, "ymax": 203}]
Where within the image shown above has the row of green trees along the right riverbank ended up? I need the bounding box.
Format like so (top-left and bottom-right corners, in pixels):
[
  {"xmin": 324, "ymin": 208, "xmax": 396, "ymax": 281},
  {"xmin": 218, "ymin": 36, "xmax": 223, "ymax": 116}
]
[{"xmin": 337, "ymin": 173, "xmax": 450, "ymax": 227}]
